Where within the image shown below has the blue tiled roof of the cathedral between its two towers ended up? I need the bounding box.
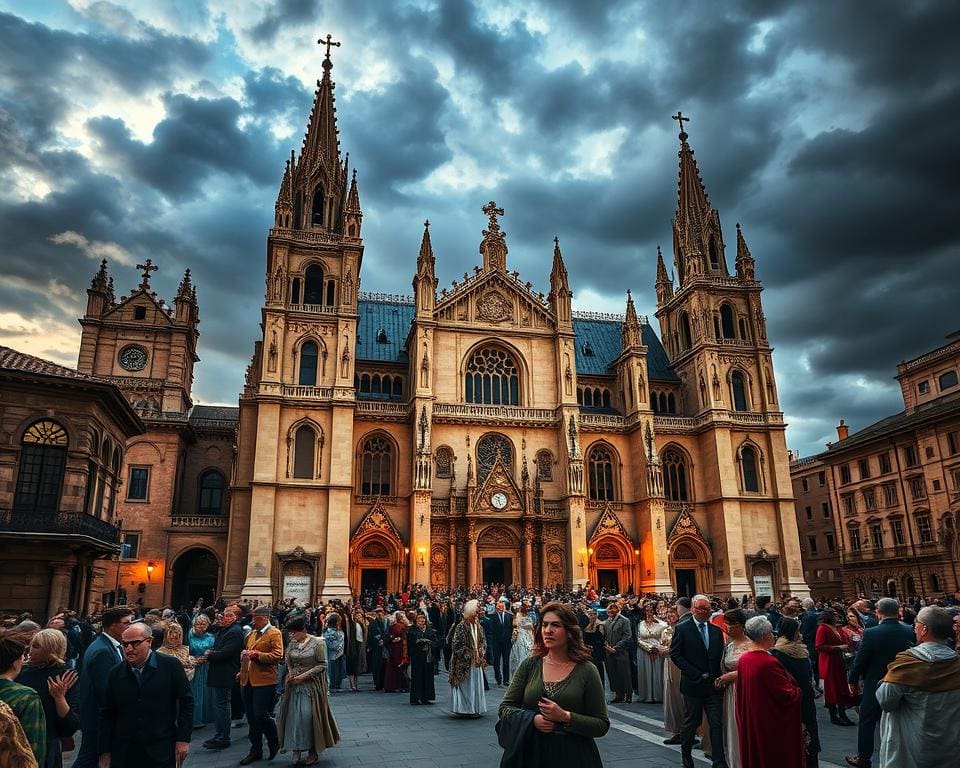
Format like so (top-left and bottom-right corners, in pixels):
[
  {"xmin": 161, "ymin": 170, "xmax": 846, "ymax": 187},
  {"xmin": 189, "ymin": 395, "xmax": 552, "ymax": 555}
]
[{"xmin": 356, "ymin": 300, "xmax": 679, "ymax": 381}]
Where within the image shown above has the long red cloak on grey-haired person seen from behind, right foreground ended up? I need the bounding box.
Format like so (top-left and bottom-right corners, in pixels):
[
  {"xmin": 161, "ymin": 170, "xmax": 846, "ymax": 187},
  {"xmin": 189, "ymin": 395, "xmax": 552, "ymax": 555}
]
[{"xmin": 736, "ymin": 651, "xmax": 805, "ymax": 768}]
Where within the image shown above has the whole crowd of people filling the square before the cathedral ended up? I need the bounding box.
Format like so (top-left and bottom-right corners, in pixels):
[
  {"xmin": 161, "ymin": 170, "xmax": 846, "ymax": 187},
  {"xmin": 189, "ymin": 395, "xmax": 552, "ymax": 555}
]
[{"xmin": 0, "ymin": 584, "xmax": 960, "ymax": 768}]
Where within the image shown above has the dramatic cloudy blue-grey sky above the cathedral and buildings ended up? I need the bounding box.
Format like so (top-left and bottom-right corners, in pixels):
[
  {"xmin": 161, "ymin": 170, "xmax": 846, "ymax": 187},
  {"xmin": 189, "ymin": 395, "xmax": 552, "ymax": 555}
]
[{"xmin": 0, "ymin": 0, "xmax": 960, "ymax": 453}]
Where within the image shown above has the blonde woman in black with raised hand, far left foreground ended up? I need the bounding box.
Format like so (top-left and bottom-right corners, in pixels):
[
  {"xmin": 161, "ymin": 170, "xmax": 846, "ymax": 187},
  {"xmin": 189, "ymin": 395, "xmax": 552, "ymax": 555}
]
[{"xmin": 17, "ymin": 629, "xmax": 80, "ymax": 768}]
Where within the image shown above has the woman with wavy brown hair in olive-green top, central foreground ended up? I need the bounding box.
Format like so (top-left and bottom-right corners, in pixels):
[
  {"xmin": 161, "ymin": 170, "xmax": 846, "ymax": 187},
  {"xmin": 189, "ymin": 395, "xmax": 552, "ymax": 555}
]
[{"xmin": 497, "ymin": 602, "xmax": 610, "ymax": 768}]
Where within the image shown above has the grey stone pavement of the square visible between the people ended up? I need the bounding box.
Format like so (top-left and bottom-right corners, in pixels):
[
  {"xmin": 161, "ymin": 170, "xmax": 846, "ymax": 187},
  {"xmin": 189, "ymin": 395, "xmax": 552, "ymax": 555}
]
[{"xmin": 64, "ymin": 672, "xmax": 856, "ymax": 768}]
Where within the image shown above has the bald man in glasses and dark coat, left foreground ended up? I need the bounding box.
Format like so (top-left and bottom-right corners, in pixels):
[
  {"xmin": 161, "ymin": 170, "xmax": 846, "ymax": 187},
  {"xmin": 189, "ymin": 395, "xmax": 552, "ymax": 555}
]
[{"xmin": 97, "ymin": 623, "xmax": 193, "ymax": 768}]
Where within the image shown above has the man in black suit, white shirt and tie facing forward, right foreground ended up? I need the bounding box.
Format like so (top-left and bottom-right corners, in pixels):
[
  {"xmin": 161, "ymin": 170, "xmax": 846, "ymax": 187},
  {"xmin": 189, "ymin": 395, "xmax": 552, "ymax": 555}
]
[{"xmin": 670, "ymin": 595, "xmax": 727, "ymax": 768}]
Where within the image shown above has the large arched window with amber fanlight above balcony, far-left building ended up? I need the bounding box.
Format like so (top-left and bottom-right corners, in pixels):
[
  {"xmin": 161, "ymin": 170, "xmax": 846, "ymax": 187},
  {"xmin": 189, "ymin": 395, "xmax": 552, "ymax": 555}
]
[{"xmin": 13, "ymin": 419, "xmax": 68, "ymax": 514}]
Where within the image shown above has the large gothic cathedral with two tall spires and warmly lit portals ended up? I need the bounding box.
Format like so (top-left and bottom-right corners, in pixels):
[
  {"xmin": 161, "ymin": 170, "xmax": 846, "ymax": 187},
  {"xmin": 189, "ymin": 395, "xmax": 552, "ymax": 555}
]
[{"xmin": 221, "ymin": 48, "xmax": 808, "ymax": 600}]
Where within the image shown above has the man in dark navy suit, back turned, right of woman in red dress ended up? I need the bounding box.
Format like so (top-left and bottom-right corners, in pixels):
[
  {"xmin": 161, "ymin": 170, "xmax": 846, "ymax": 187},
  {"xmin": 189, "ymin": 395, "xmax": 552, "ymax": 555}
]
[{"xmin": 846, "ymin": 597, "xmax": 916, "ymax": 768}]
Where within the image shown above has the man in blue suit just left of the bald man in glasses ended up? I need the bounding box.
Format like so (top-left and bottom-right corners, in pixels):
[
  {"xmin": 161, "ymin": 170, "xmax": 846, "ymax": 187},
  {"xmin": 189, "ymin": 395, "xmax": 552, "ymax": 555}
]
[{"xmin": 73, "ymin": 606, "xmax": 133, "ymax": 768}]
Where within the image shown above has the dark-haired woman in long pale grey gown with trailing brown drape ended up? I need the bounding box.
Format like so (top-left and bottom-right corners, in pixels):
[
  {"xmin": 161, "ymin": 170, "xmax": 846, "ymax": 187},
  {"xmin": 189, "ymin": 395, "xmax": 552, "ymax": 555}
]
[{"xmin": 277, "ymin": 616, "xmax": 340, "ymax": 765}]
